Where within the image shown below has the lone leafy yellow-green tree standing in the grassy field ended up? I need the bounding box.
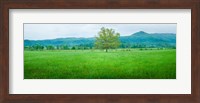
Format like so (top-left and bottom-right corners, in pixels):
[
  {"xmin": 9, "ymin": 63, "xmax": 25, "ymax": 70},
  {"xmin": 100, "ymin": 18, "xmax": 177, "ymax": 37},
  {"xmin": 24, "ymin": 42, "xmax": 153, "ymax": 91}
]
[{"xmin": 95, "ymin": 27, "xmax": 120, "ymax": 52}]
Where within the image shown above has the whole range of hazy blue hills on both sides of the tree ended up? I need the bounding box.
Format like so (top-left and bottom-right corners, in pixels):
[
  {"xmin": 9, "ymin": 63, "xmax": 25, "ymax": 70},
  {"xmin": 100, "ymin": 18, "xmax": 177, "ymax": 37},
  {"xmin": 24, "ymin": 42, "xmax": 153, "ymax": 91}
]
[{"xmin": 24, "ymin": 31, "xmax": 176, "ymax": 48}]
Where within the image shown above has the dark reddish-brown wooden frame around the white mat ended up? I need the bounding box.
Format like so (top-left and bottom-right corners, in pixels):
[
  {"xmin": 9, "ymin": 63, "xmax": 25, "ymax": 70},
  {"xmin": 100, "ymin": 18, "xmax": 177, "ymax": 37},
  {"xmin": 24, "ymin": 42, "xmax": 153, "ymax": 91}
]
[{"xmin": 0, "ymin": 0, "xmax": 200, "ymax": 103}]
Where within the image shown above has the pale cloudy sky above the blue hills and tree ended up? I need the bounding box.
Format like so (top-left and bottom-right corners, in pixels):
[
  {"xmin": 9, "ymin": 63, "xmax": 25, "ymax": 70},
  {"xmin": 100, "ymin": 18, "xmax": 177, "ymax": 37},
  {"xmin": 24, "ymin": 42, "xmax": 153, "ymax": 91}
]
[{"xmin": 24, "ymin": 23, "xmax": 176, "ymax": 40}]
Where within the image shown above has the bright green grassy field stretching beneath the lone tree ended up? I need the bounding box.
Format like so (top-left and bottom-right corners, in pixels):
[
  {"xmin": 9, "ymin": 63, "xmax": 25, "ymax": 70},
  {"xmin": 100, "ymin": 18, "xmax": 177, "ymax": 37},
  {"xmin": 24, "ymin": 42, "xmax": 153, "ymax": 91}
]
[{"xmin": 24, "ymin": 49, "xmax": 176, "ymax": 79}]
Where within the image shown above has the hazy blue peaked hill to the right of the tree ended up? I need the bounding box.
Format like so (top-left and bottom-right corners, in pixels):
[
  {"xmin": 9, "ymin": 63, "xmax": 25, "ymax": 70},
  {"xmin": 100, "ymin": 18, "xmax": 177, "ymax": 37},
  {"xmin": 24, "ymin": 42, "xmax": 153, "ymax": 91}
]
[{"xmin": 120, "ymin": 31, "xmax": 176, "ymax": 47}]
